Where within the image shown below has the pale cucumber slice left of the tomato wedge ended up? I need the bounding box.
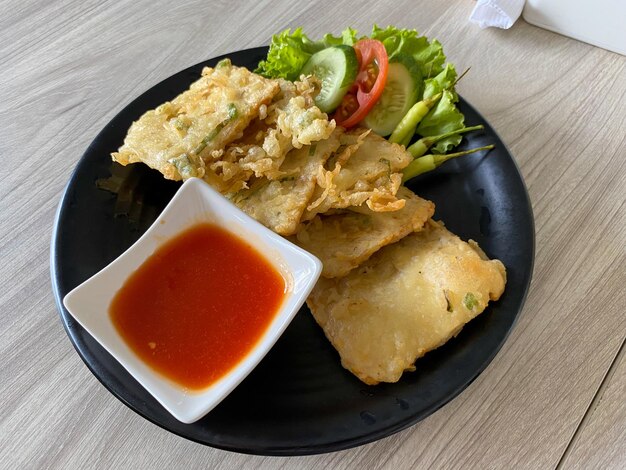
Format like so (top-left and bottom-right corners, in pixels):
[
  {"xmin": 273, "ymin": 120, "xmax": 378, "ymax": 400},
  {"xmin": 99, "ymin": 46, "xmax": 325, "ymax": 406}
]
[{"xmin": 300, "ymin": 45, "xmax": 359, "ymax": 113}]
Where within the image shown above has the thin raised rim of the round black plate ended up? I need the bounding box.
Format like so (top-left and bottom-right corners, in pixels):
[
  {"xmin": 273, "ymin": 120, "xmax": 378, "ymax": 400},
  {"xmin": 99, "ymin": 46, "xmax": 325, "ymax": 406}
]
[{"xmin": 50, "ymin": 46, "xmax": 536, "ymax": 456}]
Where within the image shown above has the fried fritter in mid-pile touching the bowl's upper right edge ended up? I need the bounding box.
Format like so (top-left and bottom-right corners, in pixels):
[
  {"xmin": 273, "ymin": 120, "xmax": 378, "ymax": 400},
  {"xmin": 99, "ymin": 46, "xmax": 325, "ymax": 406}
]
[{"xmin": 231, "ymin": 128, "xmax": 343, "ymax": 235}]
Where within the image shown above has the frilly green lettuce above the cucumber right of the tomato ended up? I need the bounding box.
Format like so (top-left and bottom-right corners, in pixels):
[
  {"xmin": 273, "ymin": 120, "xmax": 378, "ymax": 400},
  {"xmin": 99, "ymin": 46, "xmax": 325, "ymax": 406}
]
[{"xmin": 370, "ymin": 25, "xmax": 446, "ymax": 77}]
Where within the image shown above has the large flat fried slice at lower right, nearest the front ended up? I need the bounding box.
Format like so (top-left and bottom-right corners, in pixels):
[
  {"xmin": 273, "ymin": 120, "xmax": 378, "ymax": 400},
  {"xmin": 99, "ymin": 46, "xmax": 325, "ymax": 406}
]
[{"xmin": 307, "ymin": 221, "xmax": 506, "ymax": 385}]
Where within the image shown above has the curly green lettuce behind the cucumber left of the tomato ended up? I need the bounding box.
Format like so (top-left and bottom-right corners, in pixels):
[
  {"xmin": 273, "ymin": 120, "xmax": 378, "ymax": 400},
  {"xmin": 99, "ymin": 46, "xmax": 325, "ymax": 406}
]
[{"xmin": 255, "ymin": 28, "xmax": 357, "ymax": 81}]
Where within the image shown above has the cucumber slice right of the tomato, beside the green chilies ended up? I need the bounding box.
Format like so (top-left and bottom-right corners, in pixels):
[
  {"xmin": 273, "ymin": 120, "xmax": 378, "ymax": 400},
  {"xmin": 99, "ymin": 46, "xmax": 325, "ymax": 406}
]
[{"xmin": 362, "ymin": 55, "xmax": 424, "ymax": 136}]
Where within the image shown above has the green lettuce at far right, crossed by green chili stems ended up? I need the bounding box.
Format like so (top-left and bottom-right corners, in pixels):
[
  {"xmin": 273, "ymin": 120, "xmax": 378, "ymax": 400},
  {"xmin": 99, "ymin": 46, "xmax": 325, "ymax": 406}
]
[{"xmin": 417, "ymin": 90, "xmax": 465, "ymax": 153}]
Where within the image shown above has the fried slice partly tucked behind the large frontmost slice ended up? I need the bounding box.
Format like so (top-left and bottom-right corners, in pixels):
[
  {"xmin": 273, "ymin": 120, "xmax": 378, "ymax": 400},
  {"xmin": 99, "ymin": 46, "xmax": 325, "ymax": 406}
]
[{"xmin": 292, "ymin": 186, "xmax": 435, "ymax": 278}]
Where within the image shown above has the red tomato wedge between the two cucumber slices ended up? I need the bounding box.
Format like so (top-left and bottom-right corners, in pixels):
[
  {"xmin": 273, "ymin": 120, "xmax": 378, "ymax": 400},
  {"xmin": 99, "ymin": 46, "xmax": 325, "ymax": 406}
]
[{"xmin": 333, "ymin": 39, "xmax": 389, "ymax": 128}]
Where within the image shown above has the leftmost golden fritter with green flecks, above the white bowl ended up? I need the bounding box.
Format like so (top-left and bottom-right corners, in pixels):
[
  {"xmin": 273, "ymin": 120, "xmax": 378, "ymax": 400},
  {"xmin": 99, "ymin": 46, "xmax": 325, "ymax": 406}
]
[{"xmin": 111, "ymin": 60, "xmax": 280, "ymax": 182}]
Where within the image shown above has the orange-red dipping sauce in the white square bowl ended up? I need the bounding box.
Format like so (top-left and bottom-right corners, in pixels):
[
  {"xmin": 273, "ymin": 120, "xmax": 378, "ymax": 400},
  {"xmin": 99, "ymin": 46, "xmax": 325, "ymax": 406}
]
[{"xmin": 109, "ymin": 223, "xmax": 285, "ymax": 390}]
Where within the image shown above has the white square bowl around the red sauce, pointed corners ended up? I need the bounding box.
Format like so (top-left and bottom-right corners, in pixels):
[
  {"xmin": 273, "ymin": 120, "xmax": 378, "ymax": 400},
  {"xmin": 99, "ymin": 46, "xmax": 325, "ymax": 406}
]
[{"xmin": 63, "ymin": 178, "xmax": 322, "ymax": 423}]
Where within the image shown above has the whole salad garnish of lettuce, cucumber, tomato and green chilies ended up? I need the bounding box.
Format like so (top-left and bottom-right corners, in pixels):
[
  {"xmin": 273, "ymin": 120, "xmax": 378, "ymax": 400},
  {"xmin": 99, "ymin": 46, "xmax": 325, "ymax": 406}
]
[{"xmin": 255, "ymin": 25, "xmax": 492, "ymax": 180}]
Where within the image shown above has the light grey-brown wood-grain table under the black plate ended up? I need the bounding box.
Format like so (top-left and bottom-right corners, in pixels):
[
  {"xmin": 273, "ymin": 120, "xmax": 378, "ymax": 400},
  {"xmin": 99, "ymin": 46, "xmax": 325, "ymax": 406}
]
[{"xmin": 0, "ymin": 0, "xmax": 626, "ymax": 469}]
